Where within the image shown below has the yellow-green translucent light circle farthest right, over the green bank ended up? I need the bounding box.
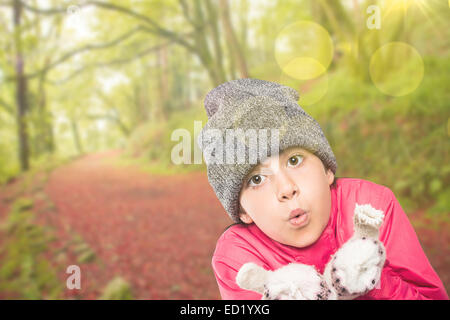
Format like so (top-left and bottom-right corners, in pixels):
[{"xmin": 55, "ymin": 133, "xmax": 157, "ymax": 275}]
[{"xmin": 369, "ymin": 42, "xmax": 424, "ymax": 97}]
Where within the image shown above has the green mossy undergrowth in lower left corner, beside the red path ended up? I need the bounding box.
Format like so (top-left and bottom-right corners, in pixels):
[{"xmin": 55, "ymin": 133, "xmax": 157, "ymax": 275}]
[{"xmin": 0, "ymin": 198, "xmax": 62, "ymax": 299}]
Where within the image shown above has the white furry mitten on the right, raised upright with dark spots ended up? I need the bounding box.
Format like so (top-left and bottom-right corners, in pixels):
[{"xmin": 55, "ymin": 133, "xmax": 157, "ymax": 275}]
[{"xmin": 324, "ymin": 204, "xmax": 386, "ymax": 300}]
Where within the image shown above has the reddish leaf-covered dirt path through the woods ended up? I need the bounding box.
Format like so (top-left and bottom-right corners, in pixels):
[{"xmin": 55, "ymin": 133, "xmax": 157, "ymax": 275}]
[{"xmin": 0, "ymin": 152, "xmax": 450, "ymax": 299}]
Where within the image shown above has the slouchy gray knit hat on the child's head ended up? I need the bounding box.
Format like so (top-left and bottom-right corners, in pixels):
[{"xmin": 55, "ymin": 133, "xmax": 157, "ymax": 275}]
[{"xmin": 197, "ymin": 78, "xmax": 337, "ymax": 222}]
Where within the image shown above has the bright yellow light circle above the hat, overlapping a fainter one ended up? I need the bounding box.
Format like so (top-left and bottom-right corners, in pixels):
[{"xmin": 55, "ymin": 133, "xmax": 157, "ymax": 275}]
[{"xmin": 275, "ymin": 21, "xmax": 334, "ymax": 80}]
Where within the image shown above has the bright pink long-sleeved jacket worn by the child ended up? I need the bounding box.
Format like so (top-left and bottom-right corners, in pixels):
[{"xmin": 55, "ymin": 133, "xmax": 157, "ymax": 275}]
[{"xmin": 212, "ymin": 178, "xmax": 448, "ymax": 300}]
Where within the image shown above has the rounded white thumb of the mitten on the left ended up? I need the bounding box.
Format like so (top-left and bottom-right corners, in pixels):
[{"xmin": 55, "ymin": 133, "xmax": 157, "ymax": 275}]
[{"xmin": 236, "ymin": 262, "xmax": 270, "ymax": 294}]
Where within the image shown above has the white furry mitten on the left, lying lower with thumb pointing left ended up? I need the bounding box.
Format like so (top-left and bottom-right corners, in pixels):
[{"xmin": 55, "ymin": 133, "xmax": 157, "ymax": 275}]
[{"xmin": 236, "ymin": 262, "xmax": 333, "ymax": 300}]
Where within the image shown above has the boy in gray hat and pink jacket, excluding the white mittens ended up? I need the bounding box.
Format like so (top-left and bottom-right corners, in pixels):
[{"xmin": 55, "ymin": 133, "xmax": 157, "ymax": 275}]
[{"xmin": 198, "ymin": 79, "xmax": 448, "ymax": 299}]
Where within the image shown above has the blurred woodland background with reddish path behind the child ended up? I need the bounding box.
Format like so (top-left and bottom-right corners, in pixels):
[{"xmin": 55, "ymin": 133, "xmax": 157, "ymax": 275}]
[{"xmin": 0, "ymin": 0, "xmax": 450, "ymax": 299}]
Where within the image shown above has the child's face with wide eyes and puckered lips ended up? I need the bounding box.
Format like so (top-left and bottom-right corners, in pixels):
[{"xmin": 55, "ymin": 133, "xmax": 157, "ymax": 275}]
[{"xmin": 239, "ymin": 147, "xmax": 334, "ymax": 247}]
